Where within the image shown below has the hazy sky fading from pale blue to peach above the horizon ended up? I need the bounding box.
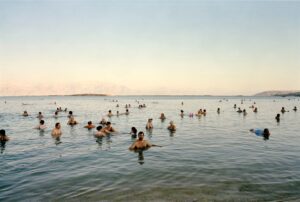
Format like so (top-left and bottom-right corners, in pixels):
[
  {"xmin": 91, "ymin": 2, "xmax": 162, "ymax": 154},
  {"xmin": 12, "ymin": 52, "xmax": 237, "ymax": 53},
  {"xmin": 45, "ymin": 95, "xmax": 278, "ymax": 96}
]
[{"xmin": 0, "ymin": 0, "xmax": 300, "ymax": 96}]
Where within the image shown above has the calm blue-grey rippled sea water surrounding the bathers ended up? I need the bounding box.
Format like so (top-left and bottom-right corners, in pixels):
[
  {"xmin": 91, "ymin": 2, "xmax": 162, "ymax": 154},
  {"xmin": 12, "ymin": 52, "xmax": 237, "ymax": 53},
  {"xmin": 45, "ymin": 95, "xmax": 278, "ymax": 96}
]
[{"xmin": 0, "ymin": 96, "xmax": 300, "ymax": 201}]
